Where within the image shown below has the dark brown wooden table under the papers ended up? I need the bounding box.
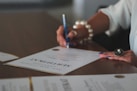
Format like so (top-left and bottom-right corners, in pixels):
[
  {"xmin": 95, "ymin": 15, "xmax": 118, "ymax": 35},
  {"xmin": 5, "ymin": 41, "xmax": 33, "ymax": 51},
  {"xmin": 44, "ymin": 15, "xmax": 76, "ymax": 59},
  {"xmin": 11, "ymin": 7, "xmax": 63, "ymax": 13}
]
[{"xmin": 0, "ymin": 11, "xmax": 137, "ymax": 78}]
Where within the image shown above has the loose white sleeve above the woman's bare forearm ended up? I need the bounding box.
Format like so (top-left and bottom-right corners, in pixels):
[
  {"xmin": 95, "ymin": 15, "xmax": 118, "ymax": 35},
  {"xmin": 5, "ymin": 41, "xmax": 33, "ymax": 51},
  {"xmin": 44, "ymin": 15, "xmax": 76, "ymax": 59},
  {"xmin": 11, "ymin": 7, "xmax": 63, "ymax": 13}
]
[{"xmin": 100, "ymin": 0, "xmax": 131, "ymax": 35}]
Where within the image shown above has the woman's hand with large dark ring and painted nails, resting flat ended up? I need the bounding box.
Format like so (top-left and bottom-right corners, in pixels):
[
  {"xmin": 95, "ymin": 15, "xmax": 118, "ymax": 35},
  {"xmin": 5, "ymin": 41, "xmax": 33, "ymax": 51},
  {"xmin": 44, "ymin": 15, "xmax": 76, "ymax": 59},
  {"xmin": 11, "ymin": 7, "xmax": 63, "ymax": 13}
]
[{"xmin": 100, "ymin": 50, "xmax": 137, "ymax": 66}]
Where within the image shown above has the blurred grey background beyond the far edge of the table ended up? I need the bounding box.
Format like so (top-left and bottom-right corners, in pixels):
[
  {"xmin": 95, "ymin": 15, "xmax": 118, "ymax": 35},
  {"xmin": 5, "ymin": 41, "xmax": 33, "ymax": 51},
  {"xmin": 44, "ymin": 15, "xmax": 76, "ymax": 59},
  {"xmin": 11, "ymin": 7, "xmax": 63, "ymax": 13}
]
[{"xmin": 0, "ymin": 0, "xmax": 118, "ymax": 24}]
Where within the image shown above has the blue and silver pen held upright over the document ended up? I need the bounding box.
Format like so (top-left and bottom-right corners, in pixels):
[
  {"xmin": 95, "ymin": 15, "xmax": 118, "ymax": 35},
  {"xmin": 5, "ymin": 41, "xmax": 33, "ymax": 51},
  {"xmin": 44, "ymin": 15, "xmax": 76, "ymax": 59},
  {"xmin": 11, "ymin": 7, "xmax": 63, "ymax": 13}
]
[{"xmin": 62, "ymin": 14, "xmax": 70, "ymax": 48}]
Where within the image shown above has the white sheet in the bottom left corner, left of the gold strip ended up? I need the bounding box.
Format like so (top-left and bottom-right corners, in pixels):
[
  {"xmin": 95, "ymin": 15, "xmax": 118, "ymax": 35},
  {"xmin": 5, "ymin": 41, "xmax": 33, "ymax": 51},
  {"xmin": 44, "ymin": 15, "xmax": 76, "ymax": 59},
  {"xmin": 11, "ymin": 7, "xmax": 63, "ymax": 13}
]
[{"xmin": 0, "ymin": 78, "xmax": 30, "ymax": 91}]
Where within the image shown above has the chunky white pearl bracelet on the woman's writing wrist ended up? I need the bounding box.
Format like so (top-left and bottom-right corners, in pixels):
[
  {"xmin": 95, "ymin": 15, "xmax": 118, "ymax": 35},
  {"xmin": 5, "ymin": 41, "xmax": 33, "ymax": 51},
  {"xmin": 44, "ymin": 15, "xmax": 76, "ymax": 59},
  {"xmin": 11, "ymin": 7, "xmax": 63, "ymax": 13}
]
[{"xmin": 73, "ymin": 21, "xmax": 93, "ymax": 43}]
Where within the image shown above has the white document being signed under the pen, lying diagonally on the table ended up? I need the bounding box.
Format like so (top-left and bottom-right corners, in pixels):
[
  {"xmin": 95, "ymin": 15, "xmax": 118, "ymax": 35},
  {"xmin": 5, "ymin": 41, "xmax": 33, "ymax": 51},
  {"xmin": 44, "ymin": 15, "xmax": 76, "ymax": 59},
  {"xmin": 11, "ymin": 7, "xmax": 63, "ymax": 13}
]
[{"xmin": 7, "ymin": 46, "xmax": 99, "ymax": 74}]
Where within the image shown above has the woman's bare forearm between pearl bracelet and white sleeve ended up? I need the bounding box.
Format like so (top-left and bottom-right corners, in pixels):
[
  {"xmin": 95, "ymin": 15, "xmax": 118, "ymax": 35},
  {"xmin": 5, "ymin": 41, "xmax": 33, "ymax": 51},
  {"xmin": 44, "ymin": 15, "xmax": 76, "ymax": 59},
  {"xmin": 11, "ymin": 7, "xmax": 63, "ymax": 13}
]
[{"xmin": 87, "ymin": 11, "xmax": 109, "ymax": 34}]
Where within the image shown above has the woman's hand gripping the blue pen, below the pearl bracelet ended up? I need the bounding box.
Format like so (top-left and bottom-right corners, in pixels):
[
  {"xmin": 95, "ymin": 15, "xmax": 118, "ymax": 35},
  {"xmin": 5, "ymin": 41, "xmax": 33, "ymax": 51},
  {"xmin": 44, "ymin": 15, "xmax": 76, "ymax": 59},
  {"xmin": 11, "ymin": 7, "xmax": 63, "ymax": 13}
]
[{"xmin": 56, "ymin": 25, "xmax": 88, "ymax": 47}]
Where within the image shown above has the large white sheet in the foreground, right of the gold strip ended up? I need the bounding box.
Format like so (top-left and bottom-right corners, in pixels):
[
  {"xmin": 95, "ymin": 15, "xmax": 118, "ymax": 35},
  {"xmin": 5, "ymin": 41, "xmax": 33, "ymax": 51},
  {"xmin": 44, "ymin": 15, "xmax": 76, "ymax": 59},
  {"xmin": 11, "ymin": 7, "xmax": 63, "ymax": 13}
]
[{"xmin": 32, "ymin": 74, "xmax": 137, "ymax": 91}]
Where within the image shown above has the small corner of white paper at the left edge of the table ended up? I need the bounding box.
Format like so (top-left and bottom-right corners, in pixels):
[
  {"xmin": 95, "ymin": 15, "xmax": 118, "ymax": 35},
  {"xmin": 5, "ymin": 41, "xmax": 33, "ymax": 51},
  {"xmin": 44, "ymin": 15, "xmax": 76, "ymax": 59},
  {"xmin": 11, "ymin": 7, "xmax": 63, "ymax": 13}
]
[{"xmin": 0, "ymin": 52, "xmax": 18, "ymax": 62}]
